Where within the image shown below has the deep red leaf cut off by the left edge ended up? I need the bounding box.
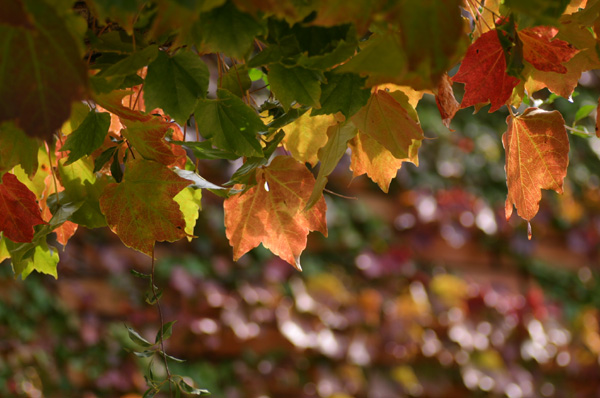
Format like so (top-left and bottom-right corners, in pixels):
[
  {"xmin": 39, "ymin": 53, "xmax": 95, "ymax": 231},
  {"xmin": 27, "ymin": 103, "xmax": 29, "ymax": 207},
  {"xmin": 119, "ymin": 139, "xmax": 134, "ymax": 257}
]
[{"xmin": 0, "ymin": 173, "xmax": 46, "ymax": 242}]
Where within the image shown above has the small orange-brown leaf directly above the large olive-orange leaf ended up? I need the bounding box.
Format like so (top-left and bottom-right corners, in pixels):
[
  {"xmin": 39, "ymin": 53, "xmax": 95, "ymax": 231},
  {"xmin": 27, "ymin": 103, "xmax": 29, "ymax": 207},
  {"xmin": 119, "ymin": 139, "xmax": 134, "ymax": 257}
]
[{"xmin": 121, "ymin": 117, "xmax": 177, "ymax": 165}]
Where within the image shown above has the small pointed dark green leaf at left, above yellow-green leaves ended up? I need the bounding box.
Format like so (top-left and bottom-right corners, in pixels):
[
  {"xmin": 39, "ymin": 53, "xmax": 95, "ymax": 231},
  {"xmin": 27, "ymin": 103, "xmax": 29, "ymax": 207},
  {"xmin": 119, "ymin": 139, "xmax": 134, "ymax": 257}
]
[{"xmin": 61, "ymin": 110, "xmax": 110, "ymax": 165}]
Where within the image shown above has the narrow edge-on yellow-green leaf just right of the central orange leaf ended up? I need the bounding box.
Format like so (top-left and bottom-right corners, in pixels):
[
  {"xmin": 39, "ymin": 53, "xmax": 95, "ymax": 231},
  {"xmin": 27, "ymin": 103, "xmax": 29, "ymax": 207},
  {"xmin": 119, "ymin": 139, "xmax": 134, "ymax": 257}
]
[{"xmin": 305, "ymin": 121, "xmax": 358, "ymax": 210}]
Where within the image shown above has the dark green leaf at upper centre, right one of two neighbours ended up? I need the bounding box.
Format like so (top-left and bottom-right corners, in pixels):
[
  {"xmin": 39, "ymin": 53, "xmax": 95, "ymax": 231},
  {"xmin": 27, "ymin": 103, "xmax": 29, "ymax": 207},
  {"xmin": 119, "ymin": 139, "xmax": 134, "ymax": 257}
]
[{"xmin": 310, "ymin": 72, "xmax": 371, "ymax": 119}]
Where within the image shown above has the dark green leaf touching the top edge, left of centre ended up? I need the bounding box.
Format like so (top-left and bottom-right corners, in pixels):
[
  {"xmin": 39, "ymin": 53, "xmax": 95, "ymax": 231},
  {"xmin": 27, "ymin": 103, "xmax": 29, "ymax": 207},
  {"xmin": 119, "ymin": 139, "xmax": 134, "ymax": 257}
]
[{"xmin": 193, "ymin": 1, "xmax": 263, "ymax": 58}]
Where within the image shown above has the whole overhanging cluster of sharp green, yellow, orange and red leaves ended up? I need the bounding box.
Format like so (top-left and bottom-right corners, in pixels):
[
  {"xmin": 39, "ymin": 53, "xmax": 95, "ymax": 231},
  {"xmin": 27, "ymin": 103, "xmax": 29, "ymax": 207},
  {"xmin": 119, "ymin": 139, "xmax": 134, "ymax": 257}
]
[{"xmin": 0, "ymin": 0, "xmax": 600, "ymax": 277}]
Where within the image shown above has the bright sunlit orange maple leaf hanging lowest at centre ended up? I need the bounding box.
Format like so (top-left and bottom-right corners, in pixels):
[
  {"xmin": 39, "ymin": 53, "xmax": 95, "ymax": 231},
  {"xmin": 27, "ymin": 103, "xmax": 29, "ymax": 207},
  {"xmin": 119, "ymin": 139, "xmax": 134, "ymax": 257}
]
[{"xmin": 223, "ymin": 156, "xmax": 327, "ymax": 269}]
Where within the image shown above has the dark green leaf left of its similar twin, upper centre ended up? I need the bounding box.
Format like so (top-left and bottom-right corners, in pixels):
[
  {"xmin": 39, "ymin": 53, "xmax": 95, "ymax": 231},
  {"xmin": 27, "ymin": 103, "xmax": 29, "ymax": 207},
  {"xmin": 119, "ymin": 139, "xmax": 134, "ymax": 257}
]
[{"xmin": 269, "ymin": 64, "xmax": 324, "ymax": 112}]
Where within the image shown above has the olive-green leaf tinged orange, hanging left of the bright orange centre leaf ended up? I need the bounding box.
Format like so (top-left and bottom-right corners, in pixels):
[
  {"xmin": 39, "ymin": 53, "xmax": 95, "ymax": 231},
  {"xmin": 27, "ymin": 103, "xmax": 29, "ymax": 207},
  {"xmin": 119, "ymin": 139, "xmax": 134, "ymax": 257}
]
[{"xmin": 100, "ymin": 160, "xmax": 191, "ymax": 256}]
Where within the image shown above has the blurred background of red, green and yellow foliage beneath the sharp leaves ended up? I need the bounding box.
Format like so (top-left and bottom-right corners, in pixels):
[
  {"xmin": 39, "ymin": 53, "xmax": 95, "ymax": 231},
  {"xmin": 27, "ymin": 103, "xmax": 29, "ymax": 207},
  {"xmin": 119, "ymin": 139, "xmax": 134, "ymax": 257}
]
[{"xmin": 0, "ymin": 73, "xmax": 600, "ymax": 398}]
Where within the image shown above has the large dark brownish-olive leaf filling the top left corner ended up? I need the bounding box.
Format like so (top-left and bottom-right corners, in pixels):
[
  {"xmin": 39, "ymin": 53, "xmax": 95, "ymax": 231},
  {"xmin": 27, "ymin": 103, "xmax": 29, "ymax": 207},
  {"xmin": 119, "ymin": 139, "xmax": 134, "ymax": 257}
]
[{"xmin": 0, "ymin": 0, "xmax": 88, "ymax": 141}]
